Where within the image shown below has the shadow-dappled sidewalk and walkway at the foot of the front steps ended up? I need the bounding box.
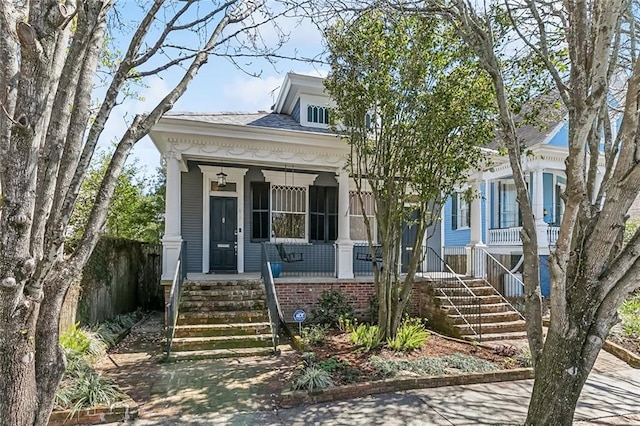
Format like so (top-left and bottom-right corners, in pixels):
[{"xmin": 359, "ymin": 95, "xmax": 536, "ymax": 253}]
[{"xmin": 105, "ymin": 312, "xmax": 640, "ymax": 426}]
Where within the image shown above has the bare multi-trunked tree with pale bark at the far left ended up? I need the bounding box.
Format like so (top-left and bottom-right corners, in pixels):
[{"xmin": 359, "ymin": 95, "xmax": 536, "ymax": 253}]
[{"xmin": 0, "ymin": 0, "xmax": 304, "ymax": 425}]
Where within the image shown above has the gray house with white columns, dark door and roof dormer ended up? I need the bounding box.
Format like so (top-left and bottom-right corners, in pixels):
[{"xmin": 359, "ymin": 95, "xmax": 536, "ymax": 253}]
[{"xmin": 150, "ymin": 73, "xmax": 441, "ymax": 280}]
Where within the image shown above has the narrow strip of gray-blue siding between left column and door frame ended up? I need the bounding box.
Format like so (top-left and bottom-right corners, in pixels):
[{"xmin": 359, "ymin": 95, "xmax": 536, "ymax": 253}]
[{"xmin": 180, "ymin": 162, "xmax": 202, "ymax": 272}]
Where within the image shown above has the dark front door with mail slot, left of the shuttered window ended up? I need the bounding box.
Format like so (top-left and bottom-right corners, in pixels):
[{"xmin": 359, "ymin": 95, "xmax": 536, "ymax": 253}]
[{"xmin": 209, "ymin": 197, "xmax": 238, "ymax": 273}]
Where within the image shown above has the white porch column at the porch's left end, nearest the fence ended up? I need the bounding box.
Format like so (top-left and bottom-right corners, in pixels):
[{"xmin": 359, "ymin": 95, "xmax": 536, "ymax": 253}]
[{"xmin": 162, "ymin": 150, "xmax": 182, "ymax": 281}]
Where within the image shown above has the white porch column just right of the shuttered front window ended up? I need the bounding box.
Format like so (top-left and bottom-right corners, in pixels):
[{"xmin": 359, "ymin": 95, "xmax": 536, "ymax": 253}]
[{"xmin": 336, "ymin": 170, "xmax": 353, "ymax": 279}]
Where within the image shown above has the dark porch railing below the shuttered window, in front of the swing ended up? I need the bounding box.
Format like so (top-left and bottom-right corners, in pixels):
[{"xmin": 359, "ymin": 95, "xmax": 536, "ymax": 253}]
[{"xmin": 262, "ymin": 243, "xmax": 336, "ymax": 278}]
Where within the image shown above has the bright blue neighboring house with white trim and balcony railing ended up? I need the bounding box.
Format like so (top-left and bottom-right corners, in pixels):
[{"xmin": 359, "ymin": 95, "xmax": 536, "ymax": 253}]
[{"xmin": 442, "ymin": 110, "xmax": 615, "ymax": 297}]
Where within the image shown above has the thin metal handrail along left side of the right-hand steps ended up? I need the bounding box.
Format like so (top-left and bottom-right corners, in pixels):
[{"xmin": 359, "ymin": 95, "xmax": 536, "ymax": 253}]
[{"xmin": 424, "ymin": 247, "xmax": 482, "ymax": 340}]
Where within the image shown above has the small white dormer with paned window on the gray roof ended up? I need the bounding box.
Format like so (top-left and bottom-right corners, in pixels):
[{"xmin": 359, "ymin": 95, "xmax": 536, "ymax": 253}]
[{"xmin": 273, "ymin": 72, "xmax": 332, "ymax": 129}]
